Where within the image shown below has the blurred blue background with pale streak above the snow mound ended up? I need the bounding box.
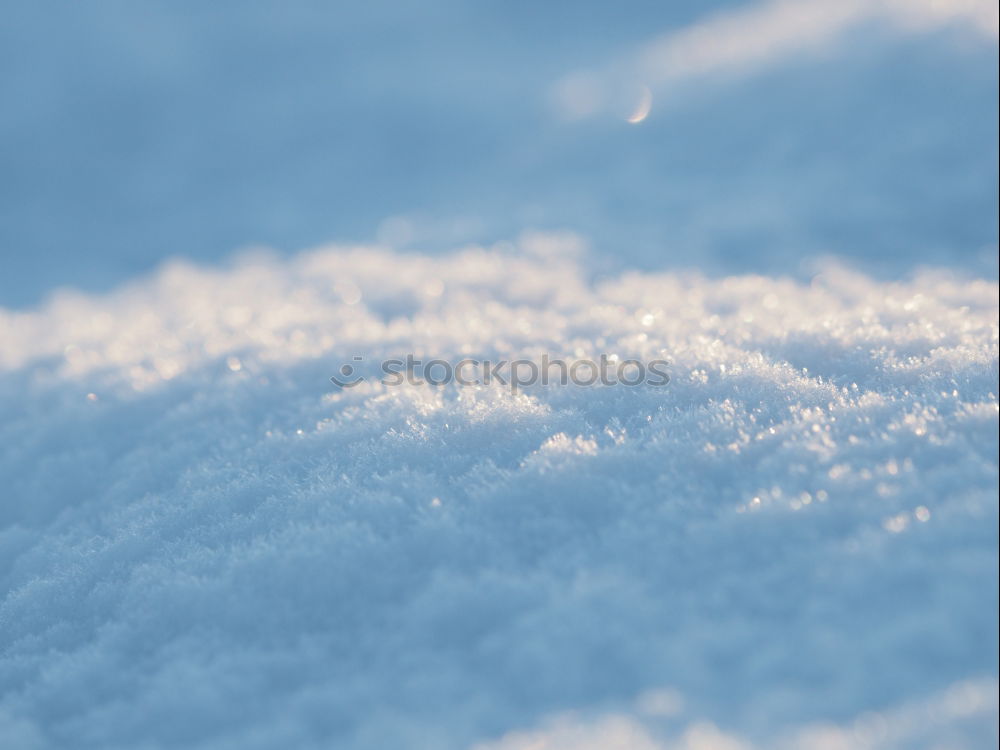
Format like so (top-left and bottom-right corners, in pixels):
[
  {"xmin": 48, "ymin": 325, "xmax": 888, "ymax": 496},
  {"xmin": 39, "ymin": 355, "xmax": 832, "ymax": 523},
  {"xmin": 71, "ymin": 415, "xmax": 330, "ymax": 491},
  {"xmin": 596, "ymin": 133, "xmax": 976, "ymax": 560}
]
[{"xmin": 0, "ymin": 0, "xmax": 998, "ymax": 307}]
